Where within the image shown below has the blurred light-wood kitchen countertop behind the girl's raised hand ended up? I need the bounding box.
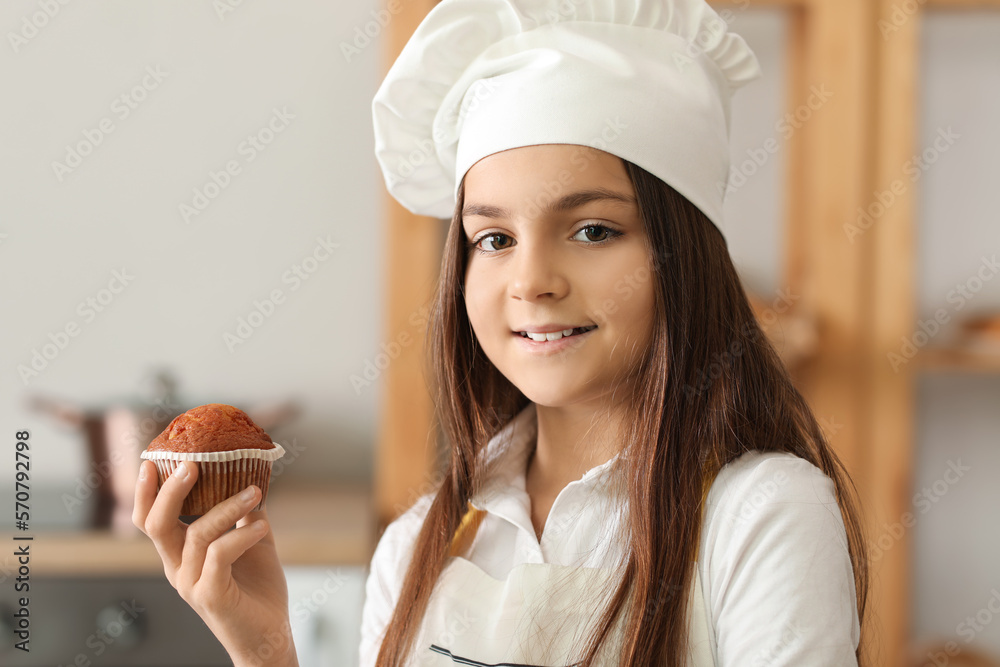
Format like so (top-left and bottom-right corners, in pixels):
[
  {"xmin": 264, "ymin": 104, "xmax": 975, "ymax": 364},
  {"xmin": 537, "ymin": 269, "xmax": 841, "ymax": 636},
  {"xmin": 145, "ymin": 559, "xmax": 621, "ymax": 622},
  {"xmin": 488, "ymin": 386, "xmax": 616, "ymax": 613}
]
[{"xmin": 0, "ymin": 483, "xmax": 376, "ymax": 581}]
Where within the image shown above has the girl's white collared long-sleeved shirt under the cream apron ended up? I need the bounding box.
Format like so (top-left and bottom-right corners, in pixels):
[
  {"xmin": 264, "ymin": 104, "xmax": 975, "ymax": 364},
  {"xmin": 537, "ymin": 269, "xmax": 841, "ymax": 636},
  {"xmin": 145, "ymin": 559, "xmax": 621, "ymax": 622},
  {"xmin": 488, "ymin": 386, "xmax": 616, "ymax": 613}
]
[{"xmin": 360, "ymin": 404, "xmax": 860, "ymax": 667}]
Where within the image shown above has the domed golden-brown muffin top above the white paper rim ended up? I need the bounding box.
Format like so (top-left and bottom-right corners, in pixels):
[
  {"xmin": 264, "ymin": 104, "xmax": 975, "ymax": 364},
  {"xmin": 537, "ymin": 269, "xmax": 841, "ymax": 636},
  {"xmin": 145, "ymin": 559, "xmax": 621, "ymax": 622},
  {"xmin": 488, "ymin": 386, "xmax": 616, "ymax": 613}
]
[{"xmin": 147, "ymin": 403, "xmax": 274, "ymax": 452}]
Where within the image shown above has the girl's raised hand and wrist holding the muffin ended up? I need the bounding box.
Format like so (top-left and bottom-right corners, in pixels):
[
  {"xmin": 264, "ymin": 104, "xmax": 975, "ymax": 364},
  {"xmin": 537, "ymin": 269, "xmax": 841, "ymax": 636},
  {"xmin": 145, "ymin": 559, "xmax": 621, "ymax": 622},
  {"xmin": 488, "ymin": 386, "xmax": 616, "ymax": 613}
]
[{"xmin": 132, "ymin": 461, "xmax": 298, "ymax": 667}]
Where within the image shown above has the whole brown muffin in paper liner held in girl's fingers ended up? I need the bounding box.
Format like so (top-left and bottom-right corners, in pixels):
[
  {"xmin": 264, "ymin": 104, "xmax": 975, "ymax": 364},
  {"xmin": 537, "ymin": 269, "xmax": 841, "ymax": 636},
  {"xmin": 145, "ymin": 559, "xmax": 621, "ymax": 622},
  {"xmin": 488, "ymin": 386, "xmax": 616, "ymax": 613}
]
[{"xmin": 140, "ymin": 403, "xmax": 285, "ymax": 516}]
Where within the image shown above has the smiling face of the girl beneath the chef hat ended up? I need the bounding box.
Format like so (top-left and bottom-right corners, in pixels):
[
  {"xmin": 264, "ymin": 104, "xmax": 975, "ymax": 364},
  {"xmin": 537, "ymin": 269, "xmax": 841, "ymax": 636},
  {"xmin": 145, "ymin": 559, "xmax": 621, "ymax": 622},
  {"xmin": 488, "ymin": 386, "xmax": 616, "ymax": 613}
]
[{"xmin": 462, "ymin": 144, "xmax": 654, "ymax": 407}]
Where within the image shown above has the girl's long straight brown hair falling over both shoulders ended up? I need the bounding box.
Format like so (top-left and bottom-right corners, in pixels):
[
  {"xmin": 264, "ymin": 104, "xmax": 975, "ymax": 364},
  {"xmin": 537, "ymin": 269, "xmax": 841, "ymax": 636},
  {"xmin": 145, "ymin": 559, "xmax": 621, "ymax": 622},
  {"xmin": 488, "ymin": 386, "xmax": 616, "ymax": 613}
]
[{"xmin": 377, "ymin": 160, "xmax": 868, "ymax": 667}]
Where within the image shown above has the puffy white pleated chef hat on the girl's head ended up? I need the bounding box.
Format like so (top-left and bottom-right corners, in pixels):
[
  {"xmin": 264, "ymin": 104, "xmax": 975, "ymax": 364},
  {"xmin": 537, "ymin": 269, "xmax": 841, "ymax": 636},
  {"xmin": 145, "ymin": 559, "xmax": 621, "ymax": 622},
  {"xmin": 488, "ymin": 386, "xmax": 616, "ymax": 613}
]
[{"xmin": 372, "ymin": 0, "xmax": 760, "ymax": 235}]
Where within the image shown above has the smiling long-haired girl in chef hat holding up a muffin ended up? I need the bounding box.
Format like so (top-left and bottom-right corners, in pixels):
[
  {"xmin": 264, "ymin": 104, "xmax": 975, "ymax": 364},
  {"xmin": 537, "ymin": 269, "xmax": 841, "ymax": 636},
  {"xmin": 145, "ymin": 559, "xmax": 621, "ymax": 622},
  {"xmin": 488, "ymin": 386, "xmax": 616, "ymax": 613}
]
[{"xmin": 133, "ymin": 0, "xmax": 867, "ymax": 667}]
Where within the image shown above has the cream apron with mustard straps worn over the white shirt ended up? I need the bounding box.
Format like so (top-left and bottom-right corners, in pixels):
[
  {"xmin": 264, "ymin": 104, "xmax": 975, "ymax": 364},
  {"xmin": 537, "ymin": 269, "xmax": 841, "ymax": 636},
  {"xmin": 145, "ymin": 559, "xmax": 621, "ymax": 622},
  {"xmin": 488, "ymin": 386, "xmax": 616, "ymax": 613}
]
[{"xmin": 408, "ymin": 504, "xmax": 715, "ymax": 667}]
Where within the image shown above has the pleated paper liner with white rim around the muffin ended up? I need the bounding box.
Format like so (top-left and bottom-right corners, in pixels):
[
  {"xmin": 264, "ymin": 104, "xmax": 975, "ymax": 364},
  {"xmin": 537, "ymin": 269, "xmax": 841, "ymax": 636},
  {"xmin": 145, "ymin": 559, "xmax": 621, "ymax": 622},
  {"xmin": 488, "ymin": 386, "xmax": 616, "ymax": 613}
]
[{"xmin": 140, "ymin": 443, "xmax": 285, "ymax": 516}]
